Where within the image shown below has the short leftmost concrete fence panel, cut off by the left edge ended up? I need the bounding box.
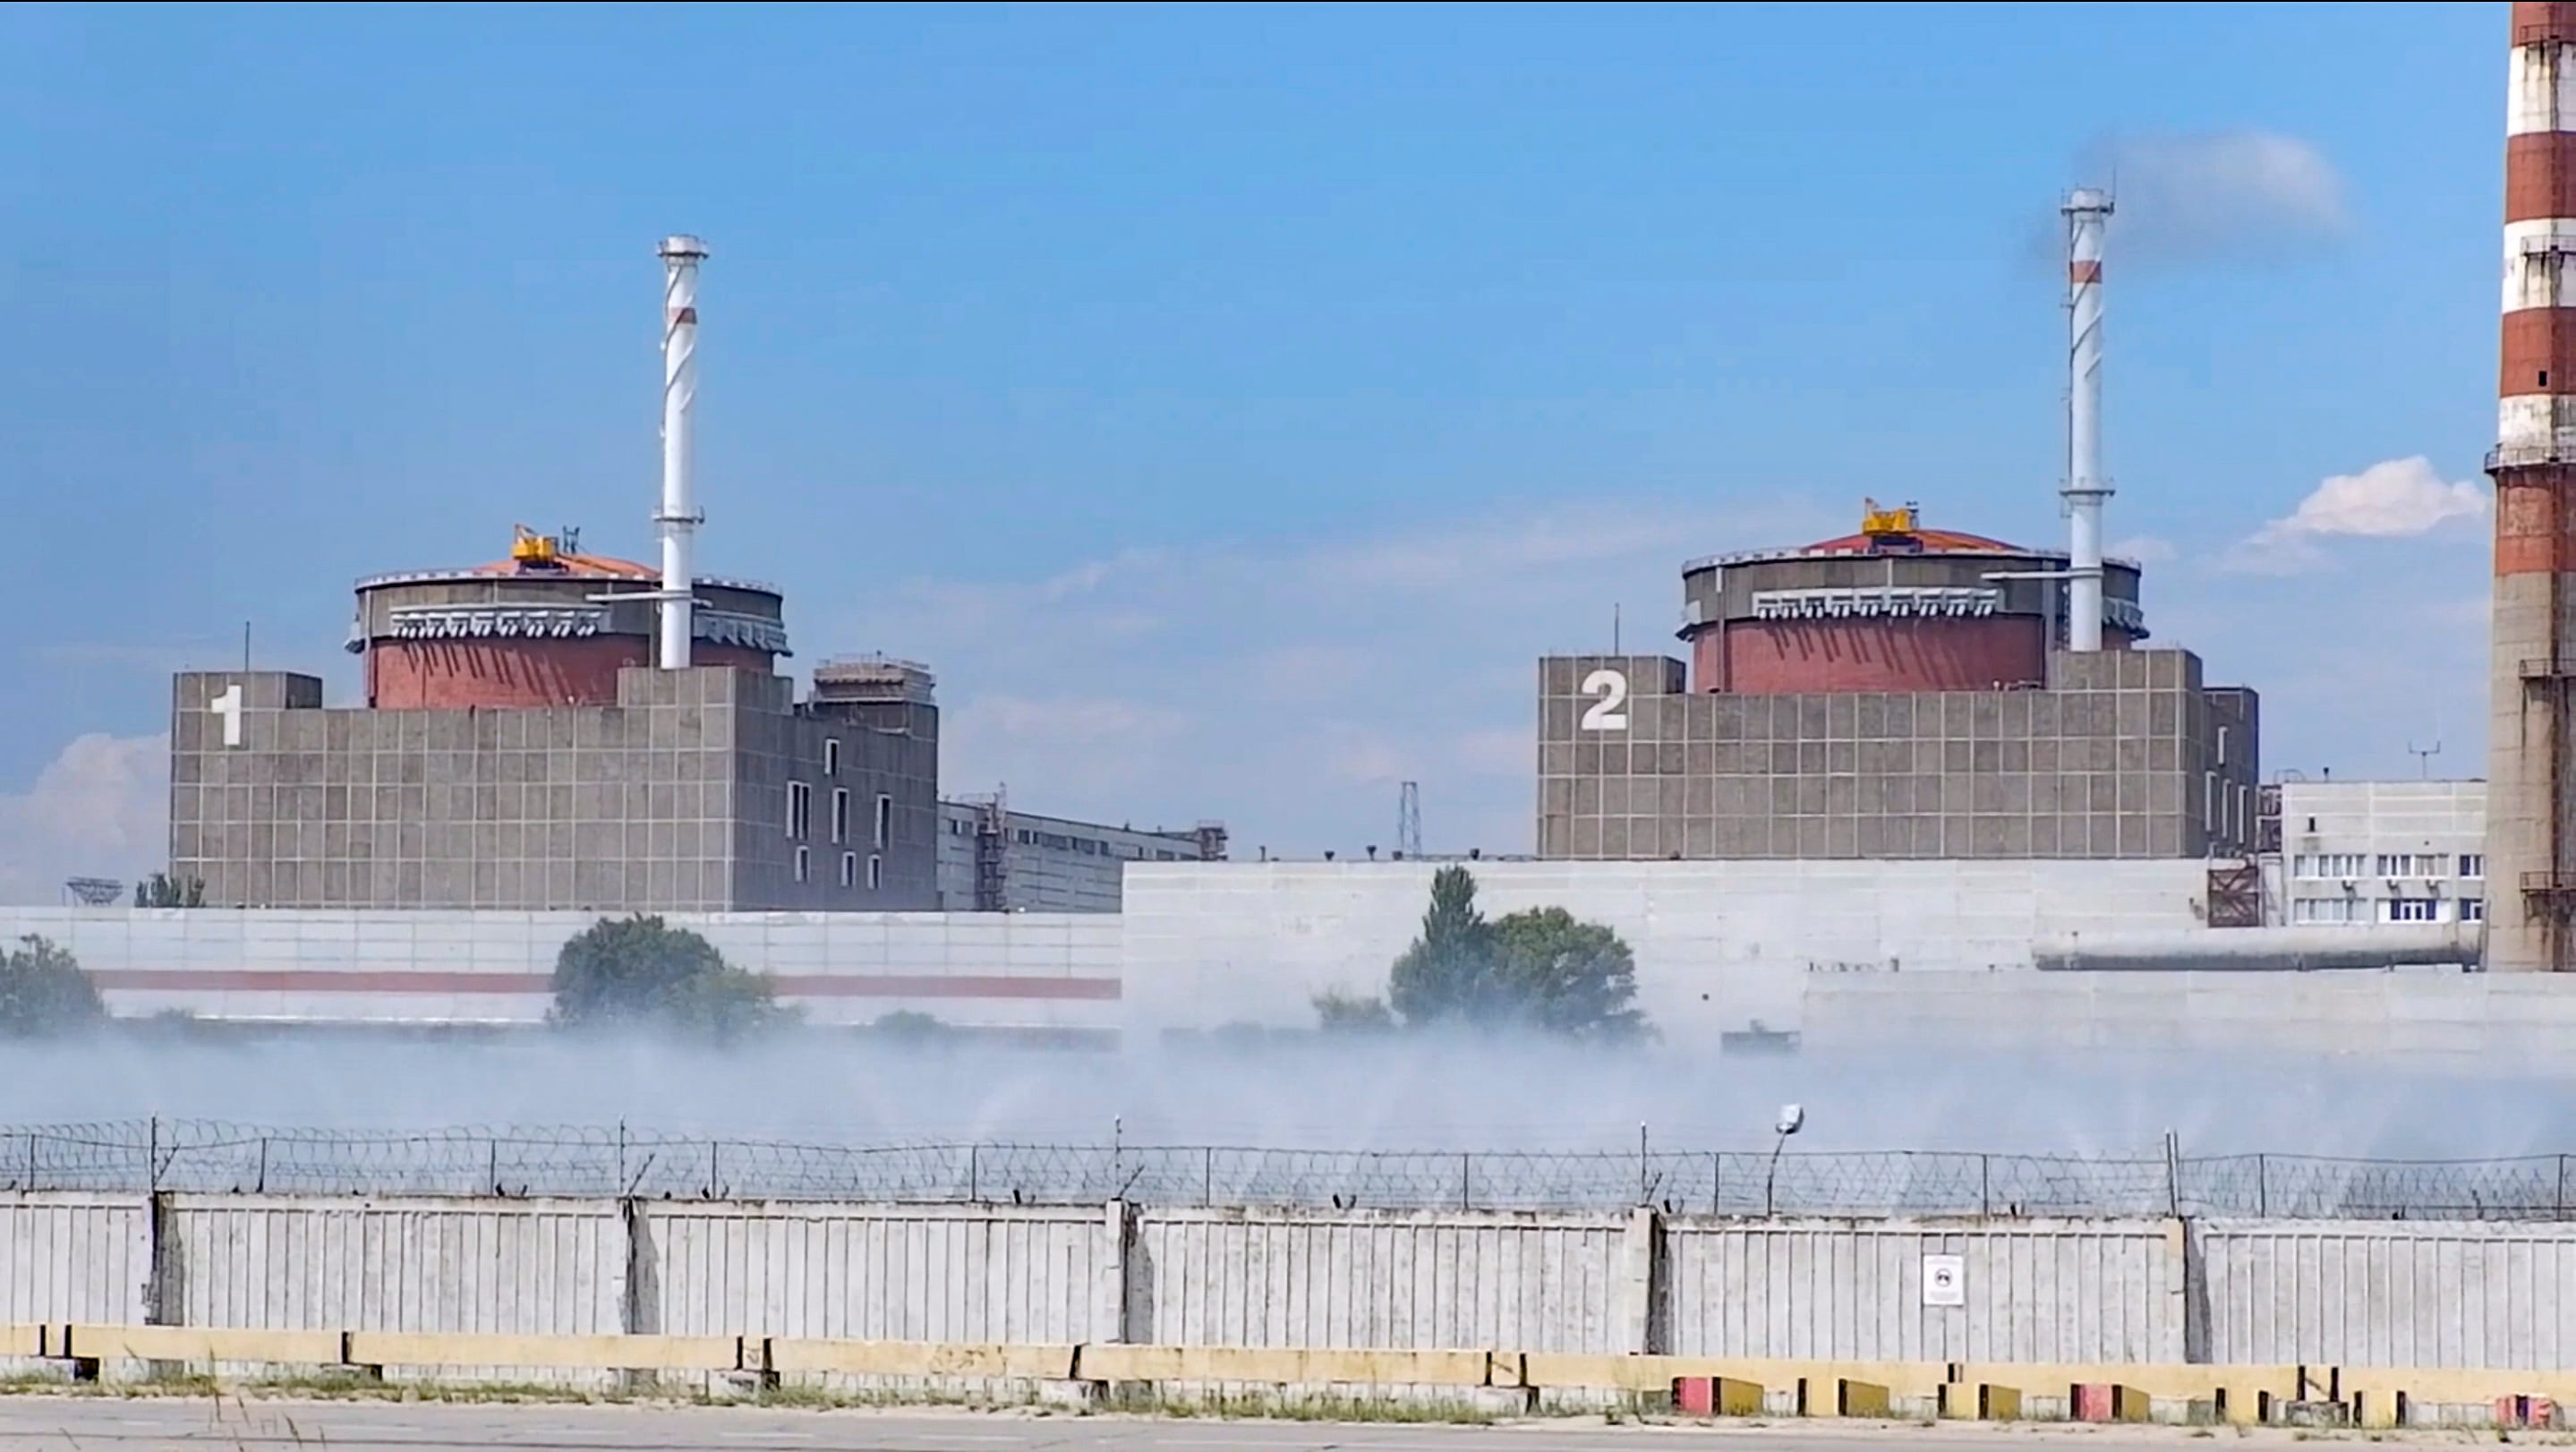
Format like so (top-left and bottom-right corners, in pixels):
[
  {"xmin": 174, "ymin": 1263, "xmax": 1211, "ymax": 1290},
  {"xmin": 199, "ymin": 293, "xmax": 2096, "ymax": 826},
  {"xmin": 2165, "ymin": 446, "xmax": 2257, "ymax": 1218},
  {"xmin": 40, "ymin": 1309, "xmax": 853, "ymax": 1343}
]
[{"xmin": 0, "ymin": 1192, "xmax": 152, "ymax": 1326}]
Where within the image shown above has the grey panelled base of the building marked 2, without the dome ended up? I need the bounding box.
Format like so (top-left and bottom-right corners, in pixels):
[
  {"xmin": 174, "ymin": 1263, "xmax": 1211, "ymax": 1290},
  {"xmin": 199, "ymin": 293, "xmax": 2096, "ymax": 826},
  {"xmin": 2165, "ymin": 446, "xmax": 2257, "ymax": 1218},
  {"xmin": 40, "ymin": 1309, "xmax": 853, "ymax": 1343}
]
[{"xmin": 1538, "ymin": 649, "xmax": 2259, "ymax": 860}]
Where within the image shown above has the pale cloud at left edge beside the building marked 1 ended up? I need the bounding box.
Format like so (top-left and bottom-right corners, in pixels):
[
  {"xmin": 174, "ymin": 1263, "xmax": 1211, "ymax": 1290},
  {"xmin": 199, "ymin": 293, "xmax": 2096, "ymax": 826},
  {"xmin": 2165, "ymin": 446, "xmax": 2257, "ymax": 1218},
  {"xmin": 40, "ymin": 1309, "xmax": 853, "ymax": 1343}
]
[{"xmin": 0, "ymin": 734, "xmax": 170, "ymax": 903}]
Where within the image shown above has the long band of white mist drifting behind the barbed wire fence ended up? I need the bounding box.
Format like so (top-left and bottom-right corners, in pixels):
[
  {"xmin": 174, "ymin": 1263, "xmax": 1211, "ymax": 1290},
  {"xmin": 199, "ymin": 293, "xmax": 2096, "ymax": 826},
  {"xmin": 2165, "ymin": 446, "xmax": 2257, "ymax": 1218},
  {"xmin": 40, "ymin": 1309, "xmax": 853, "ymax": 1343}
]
[{"xmin": 0, "ymin": 1032, "xmax": 2576, "ymax": 1158}]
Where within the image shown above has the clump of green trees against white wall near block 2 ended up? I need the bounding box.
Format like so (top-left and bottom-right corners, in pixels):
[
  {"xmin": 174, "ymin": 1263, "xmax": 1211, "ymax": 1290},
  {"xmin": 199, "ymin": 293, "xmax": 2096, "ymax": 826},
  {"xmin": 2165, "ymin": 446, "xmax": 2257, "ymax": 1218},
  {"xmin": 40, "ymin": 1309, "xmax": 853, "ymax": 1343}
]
[{"xmin": 1350, "ymin": 867, "xmax": 1646, "ymax": 1040}]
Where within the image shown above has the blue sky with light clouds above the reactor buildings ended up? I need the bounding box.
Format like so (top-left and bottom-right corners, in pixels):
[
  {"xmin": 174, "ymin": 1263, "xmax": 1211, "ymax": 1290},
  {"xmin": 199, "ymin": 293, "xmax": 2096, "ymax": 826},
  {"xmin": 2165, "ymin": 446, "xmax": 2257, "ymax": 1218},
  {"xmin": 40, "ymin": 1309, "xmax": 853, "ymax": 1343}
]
[{"xmin": 0, "ymin": 5, "xmax": 2506, "ymax": 896}]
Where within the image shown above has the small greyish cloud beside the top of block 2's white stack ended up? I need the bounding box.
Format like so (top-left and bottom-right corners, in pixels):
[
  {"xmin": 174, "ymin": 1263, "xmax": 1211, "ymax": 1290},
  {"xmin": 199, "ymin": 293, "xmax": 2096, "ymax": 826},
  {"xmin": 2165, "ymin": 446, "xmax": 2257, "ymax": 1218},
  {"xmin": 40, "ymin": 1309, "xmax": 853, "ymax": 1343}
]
[{"xmin": 2084, "ymin": 132, "xmax": 2352, "ymax": 265}]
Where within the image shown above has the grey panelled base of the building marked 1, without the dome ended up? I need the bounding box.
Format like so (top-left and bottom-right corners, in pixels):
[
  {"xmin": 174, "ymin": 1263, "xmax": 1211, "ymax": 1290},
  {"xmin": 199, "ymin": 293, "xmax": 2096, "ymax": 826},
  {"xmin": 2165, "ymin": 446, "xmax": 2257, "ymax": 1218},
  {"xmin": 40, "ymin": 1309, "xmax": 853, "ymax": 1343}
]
[{"xmin": 170, "ymin": 667, "xmax": 938, "ymax": 911}]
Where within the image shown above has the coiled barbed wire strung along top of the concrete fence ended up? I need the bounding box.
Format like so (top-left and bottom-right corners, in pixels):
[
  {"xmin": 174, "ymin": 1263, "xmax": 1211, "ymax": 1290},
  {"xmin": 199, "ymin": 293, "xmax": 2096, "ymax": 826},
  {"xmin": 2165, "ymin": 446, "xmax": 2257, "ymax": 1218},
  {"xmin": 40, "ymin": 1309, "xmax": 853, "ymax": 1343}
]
[{"xmin": 0, "ymin": 1120, "xmax": 2576, "ymax": 1220}]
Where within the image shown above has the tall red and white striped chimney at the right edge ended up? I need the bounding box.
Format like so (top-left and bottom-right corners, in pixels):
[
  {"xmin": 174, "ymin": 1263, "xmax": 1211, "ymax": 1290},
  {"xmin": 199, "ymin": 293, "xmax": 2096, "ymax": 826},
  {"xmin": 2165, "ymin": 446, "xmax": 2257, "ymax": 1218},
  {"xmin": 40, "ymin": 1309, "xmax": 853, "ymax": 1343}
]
[{"xmin": 2486, "ymin": 0, "xmax": 2576, "ymax": 970}]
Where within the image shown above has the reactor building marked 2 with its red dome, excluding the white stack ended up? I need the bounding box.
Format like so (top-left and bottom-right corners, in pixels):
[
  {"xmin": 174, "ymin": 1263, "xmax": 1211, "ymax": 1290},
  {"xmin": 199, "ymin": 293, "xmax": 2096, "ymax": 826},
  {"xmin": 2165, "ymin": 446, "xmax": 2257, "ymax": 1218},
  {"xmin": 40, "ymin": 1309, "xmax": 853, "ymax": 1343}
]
[{"xmin": 1538, "ymin": 508, "xmax": 2259, "ymax": 860}]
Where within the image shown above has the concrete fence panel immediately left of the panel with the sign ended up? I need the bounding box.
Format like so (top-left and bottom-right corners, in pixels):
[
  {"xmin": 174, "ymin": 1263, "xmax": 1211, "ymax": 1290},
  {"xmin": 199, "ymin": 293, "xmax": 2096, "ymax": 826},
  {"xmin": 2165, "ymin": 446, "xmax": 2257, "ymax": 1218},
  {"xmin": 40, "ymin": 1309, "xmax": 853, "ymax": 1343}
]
[{"xmin": 1126, "ymin": 1210, "xmax": 1643, "ymax": 1352}]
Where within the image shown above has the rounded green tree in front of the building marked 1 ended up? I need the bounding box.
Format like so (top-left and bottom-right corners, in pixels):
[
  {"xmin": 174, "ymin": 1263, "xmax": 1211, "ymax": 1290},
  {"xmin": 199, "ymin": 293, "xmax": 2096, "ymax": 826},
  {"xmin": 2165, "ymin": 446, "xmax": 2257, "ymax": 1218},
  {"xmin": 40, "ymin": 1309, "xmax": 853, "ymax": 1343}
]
[{"xmin": 551, "ymin": 914, "xmax": 793, "ymax": 1040}]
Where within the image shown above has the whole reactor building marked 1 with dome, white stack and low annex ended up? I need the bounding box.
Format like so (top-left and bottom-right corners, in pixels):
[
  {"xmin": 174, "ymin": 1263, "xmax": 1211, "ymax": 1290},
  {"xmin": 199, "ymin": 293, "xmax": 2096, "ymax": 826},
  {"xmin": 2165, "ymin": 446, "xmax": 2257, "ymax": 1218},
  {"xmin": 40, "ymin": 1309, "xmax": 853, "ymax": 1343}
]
[{"xmin": 170, "ymin": 237, "xmax": 1224, "ymax": 911}]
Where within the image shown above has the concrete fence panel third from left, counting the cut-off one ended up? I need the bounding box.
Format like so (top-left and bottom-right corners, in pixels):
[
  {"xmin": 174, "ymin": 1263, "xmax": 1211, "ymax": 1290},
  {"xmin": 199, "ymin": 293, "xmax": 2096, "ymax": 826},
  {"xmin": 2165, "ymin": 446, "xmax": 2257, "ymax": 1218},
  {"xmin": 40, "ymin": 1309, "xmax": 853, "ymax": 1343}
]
[{"xmin": 636, "ymin": 1202, "xmax": 1118, "ymax": 1344}]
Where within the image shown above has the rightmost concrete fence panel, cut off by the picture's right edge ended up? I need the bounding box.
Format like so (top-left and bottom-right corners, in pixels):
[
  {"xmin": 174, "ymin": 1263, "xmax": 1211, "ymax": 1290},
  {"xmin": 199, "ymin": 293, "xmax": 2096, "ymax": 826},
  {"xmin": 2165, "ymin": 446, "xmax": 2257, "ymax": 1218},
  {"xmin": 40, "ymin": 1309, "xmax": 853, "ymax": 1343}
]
[{"xmin": 2195, "ymin": 1220, "xmax": 2576, "ymax": 1370}]
